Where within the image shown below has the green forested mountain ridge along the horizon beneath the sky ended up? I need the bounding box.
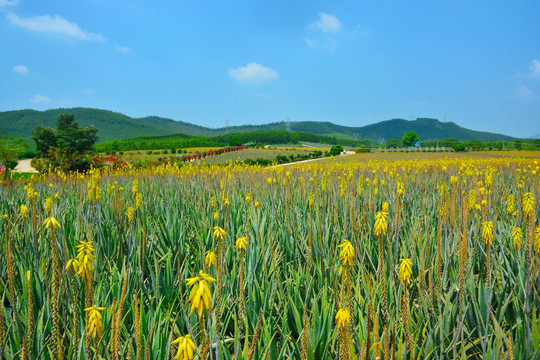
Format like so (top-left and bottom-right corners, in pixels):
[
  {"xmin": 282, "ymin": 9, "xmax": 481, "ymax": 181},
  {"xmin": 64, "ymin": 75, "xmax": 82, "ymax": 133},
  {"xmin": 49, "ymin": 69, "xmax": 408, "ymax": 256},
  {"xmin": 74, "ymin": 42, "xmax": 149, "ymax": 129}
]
[{"xmin": 0, "ymin": 108, "xmax": 515, "ymax": 142}]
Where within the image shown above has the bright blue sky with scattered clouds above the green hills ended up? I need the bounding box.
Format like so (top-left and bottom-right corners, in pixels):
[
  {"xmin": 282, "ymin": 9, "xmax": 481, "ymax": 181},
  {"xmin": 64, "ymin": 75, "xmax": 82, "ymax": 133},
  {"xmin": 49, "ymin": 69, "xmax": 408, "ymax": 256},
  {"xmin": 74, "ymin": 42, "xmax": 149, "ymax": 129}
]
[{"xmin": 0, "ymin": 0, "xmax": 540, "ymax": 137}]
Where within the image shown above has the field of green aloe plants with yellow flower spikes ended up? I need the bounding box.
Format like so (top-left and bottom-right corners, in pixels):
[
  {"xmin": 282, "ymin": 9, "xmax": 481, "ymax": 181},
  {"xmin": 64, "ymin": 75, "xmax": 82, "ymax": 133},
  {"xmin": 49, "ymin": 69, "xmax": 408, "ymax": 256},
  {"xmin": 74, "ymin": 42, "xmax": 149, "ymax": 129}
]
[{"xmin": 0, "ymin": 152, "xmax": 540, "ymax": 360}]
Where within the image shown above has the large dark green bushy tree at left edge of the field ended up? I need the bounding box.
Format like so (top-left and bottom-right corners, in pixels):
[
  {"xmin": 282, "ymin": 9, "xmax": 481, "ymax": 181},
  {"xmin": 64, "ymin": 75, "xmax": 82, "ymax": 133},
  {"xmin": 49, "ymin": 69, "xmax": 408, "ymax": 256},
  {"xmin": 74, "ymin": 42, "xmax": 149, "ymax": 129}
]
[{"xmin": 32, "ymin": 114, "xmax": 98, "ymax": 171}]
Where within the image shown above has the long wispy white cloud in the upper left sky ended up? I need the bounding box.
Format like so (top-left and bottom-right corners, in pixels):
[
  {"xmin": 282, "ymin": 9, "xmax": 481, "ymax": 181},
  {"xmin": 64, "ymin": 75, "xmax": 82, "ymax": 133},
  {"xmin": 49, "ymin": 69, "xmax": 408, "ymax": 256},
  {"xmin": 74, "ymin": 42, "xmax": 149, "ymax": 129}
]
[{"xmin": 7, "ymin": 12, "xmax": 105, "ymax": 41}]
